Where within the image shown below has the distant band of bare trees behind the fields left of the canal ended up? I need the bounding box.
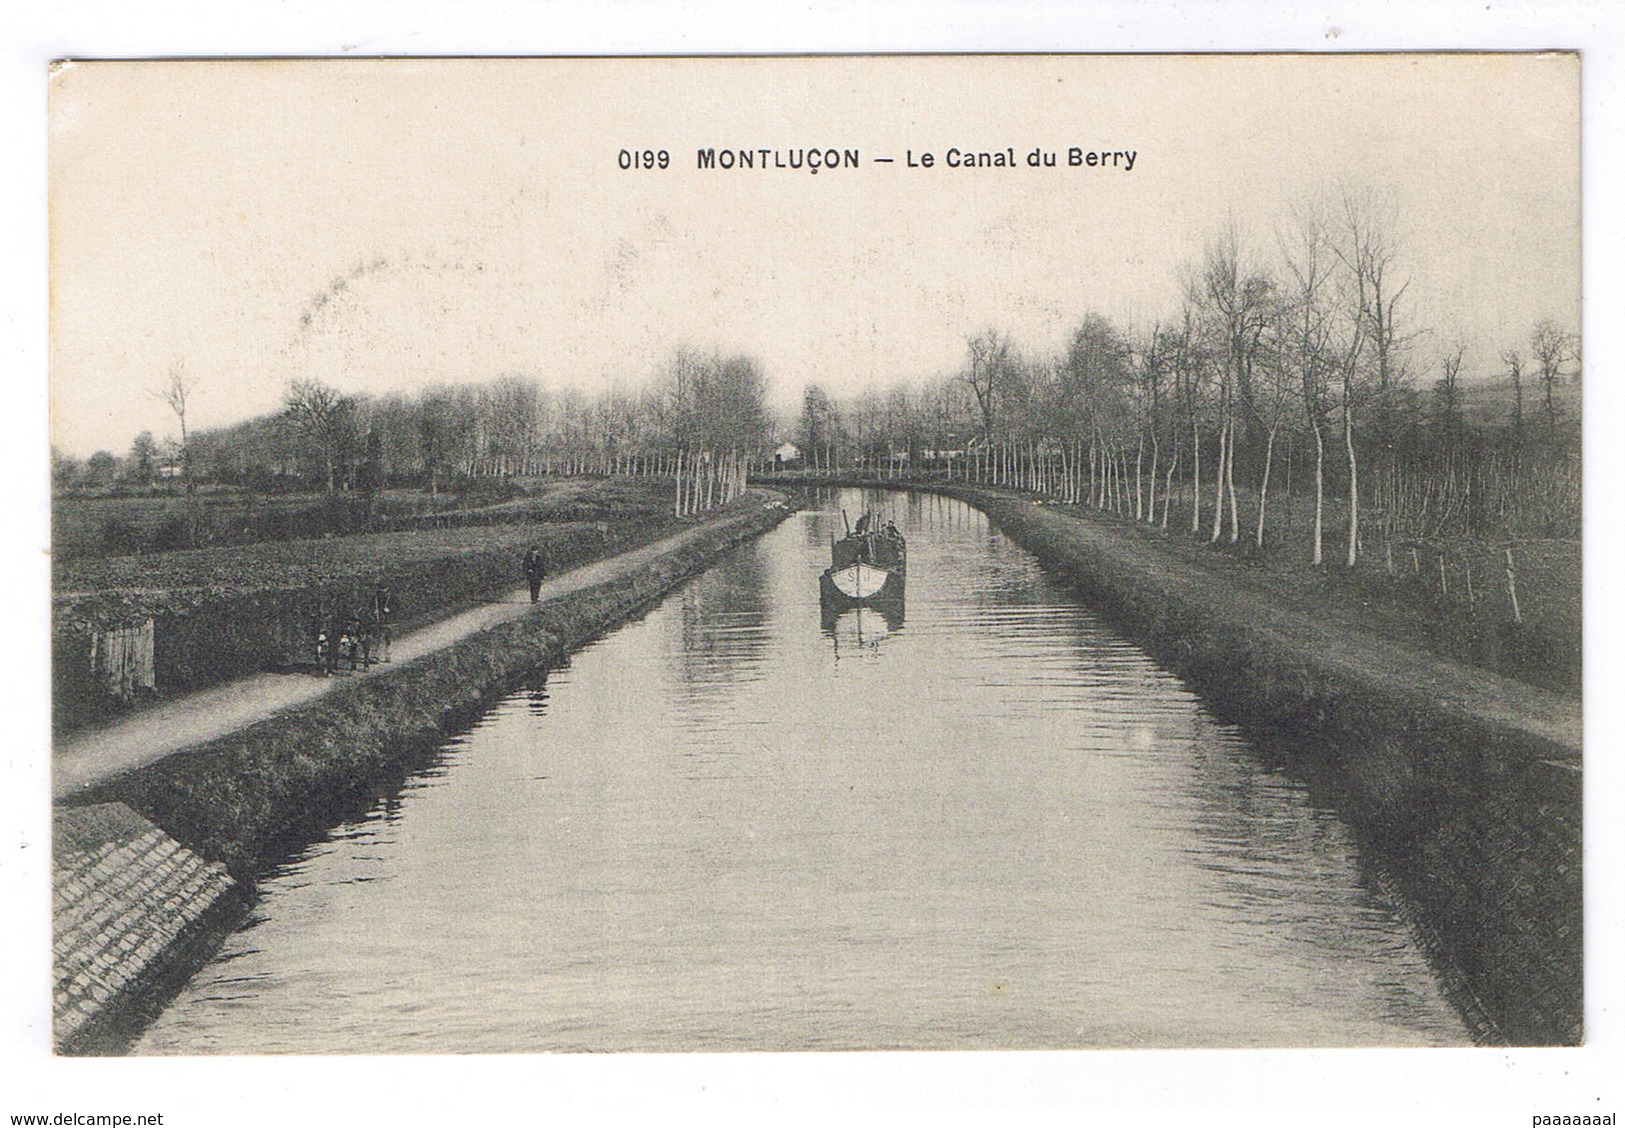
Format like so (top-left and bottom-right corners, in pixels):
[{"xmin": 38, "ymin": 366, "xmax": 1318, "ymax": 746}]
[{"xmin": 57, "ymin": 349, "xmax": 770, "ymax": 494}]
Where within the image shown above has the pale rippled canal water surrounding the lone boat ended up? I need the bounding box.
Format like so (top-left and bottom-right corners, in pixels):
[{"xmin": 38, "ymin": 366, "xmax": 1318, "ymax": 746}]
[{"xmin": 135, "ymin": 491, "xmax": 1469, "ymax": 1053}]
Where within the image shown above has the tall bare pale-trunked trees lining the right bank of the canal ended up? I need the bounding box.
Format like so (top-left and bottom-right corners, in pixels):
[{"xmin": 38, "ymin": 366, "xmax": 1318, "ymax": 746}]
[{"xmin": 796, "ymin": 193, "xmax": 1580, "ymax": 555}]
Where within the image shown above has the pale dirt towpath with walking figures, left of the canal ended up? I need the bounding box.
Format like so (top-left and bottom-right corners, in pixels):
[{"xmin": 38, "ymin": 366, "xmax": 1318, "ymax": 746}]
[{"xmin": 52, "ymin": 523, "xmax": 744, "ymax": 800}]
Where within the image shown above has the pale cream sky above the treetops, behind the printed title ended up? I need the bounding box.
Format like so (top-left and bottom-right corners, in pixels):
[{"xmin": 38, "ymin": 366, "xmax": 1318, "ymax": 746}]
[{"xmin": 50, "ymin": 54, "xmax": 1580, "ymax": 457}]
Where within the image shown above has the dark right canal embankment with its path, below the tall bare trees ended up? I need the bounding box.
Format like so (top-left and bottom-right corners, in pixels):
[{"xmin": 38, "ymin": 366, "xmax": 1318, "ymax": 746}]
[{"xmin": 943, "ymin": 488, "xmax": 1584, "ymax": 1043}]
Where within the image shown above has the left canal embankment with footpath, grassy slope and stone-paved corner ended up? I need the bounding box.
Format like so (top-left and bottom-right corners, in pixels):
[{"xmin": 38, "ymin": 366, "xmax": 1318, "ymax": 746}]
[{"xmin": 54, "ymin": 491, "xmax": 791, "ymax": 1053}]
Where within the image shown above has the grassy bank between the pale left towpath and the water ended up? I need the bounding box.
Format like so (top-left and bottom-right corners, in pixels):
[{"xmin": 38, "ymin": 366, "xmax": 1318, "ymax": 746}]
[{"xmin": 66, "ymin": 492, "xmax": 788, "ymax": 881}]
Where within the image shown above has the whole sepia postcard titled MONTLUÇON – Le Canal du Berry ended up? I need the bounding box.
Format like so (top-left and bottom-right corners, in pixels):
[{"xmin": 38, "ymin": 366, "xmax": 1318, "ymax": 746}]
[{"xmin": 28, "ymin": 52, "xmax": 1593, "ymax": 1124}]
